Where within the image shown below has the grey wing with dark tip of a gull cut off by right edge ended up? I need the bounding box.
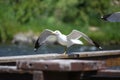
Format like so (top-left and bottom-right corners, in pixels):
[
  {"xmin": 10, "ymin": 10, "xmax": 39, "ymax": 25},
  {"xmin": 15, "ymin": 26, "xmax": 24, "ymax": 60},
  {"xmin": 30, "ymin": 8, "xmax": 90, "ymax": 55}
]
[{"xmin": 101, "ymin": 12, "xmax": 120, "ymax": 22}]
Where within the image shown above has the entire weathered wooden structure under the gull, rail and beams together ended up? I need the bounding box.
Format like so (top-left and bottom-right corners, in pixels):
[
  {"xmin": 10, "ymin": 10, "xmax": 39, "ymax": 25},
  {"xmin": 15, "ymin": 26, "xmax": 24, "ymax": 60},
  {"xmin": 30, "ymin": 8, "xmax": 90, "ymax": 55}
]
[{"xmin": 0, "ymin": 50, "xmax": 120, "ymax": 80}]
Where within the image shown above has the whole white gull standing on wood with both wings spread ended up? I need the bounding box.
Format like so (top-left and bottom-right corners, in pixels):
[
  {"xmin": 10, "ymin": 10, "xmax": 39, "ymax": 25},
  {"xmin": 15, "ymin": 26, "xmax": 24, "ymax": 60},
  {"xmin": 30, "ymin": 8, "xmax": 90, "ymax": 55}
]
[{"xmin": 34, "ymin": 29, "xmax": 102, "ymax": 54}]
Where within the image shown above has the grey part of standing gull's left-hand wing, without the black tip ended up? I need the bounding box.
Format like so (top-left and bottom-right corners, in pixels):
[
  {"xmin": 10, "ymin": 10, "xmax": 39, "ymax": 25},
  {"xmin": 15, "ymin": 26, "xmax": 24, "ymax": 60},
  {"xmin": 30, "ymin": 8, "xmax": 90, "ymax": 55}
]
[{"xmin": 38, "ymin": 29, "xmax": 53, "ymax": 45}]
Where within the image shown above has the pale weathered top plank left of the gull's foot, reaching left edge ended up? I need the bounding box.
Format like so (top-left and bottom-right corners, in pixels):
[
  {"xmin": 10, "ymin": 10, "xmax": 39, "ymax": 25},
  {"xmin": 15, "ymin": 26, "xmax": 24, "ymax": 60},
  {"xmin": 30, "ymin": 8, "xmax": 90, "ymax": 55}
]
[{"xmin": 0, "ymin": 54, "xmax": 67, "ymax": 63}]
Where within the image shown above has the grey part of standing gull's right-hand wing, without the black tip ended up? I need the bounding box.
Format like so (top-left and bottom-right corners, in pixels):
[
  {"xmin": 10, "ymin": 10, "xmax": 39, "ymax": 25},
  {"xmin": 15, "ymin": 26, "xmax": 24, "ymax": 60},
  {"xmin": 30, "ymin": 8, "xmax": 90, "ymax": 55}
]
[{"xmin": 67, "ymin": 30, "xmax": 94, "ymax": 45}]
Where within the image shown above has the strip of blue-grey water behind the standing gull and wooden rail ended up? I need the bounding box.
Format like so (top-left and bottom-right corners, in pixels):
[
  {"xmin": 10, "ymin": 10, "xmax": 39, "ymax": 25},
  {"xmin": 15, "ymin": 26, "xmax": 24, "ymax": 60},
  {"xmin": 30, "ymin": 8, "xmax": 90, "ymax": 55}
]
[{"xmin": 0, "ymin": 44, "xmax": 120, "ymax": 57}]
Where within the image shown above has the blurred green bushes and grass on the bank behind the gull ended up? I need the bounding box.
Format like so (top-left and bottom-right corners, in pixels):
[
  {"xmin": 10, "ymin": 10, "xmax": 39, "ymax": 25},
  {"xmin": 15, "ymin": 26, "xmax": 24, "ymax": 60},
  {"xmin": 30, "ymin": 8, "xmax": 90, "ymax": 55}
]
[{"xmin": 0, "ymin": 0, "xmax": 120, "ymax": 45}]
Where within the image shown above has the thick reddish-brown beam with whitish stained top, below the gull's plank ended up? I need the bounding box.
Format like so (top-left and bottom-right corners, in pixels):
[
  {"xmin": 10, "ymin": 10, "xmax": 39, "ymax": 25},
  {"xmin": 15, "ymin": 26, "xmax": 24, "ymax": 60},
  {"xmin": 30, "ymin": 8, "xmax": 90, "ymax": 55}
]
[{"xmin": 17, "ymin": 59, "xmax": 105, "ymax": 71}]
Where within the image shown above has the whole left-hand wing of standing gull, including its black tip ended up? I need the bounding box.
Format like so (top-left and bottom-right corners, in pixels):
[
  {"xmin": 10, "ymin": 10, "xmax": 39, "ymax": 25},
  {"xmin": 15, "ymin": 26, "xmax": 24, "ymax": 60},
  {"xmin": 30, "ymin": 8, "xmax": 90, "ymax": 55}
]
[{"xmin": 34, "ymin": 29, "xmax": 53, "ymax": 51}]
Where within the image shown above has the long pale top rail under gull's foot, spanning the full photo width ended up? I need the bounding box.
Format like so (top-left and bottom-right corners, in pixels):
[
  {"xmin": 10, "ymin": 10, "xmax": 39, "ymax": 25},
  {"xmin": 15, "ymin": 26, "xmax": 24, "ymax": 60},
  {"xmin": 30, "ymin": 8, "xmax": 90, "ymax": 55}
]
[{"xmin": 0, "ymin": 50, "xmax": 120, "ymax": 63}]
